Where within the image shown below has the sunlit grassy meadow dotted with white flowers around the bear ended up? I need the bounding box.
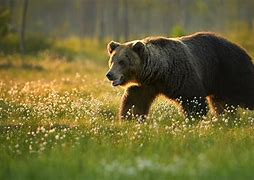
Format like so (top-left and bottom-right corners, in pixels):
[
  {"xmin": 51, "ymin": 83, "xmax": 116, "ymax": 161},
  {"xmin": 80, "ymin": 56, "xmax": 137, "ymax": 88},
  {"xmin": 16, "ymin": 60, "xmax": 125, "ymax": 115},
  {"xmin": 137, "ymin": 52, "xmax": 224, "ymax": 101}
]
[{"xmin": 0, "ymin": 36, "xmax": 254, "ymax": 180}]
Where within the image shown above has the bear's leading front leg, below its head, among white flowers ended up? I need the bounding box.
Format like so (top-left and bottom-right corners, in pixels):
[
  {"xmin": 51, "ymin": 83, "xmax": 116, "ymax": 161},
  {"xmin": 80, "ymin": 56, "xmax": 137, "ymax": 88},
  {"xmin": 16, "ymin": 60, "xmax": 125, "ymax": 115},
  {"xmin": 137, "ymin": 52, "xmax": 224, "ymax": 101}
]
[{"xmin": 119, "ymin": 86, "xmax": 157, "ymax": 119}]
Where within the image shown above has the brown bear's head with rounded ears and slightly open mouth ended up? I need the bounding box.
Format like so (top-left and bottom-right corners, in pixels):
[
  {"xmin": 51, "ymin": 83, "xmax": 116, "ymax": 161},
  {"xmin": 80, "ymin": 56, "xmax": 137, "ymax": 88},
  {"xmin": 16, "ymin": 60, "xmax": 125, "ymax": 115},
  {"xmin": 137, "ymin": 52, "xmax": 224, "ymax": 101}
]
[{"xmin": 106, "ymin": 41, "xmax": 145, "ymax": 86}]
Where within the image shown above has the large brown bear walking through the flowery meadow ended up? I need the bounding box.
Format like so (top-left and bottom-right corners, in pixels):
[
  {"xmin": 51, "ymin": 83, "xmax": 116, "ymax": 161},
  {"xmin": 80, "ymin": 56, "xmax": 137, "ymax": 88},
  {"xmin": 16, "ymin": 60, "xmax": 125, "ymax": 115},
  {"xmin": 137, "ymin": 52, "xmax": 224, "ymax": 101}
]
[{"xmin": 106, "ymin": 32, "xmax": 254, "ymax": 119}]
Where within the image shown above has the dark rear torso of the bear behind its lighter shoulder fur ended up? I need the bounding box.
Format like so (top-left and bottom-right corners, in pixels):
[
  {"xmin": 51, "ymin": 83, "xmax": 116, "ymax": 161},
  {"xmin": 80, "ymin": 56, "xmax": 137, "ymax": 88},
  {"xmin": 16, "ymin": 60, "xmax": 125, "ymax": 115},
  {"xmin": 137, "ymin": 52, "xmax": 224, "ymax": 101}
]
[{"xmin": 180, "ymin": 33, "xmax": 254, "ymax": 100}]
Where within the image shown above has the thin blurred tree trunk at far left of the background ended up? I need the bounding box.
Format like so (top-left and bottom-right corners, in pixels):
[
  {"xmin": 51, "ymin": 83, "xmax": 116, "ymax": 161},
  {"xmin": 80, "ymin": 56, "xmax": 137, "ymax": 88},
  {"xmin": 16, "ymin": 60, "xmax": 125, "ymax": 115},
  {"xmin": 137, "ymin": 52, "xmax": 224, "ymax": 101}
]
[{"xmin": 20, "ymin": 0, "xmax": 28, "ymax": 54}]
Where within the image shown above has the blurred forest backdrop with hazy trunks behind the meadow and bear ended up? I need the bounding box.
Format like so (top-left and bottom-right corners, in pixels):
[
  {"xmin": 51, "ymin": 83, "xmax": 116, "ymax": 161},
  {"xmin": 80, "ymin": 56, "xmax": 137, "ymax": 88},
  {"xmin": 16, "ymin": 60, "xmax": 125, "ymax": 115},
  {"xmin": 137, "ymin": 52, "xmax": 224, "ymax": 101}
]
[{"xmin": 0, "ymin": 0, "xmax": 254, "ymax": 58}]
